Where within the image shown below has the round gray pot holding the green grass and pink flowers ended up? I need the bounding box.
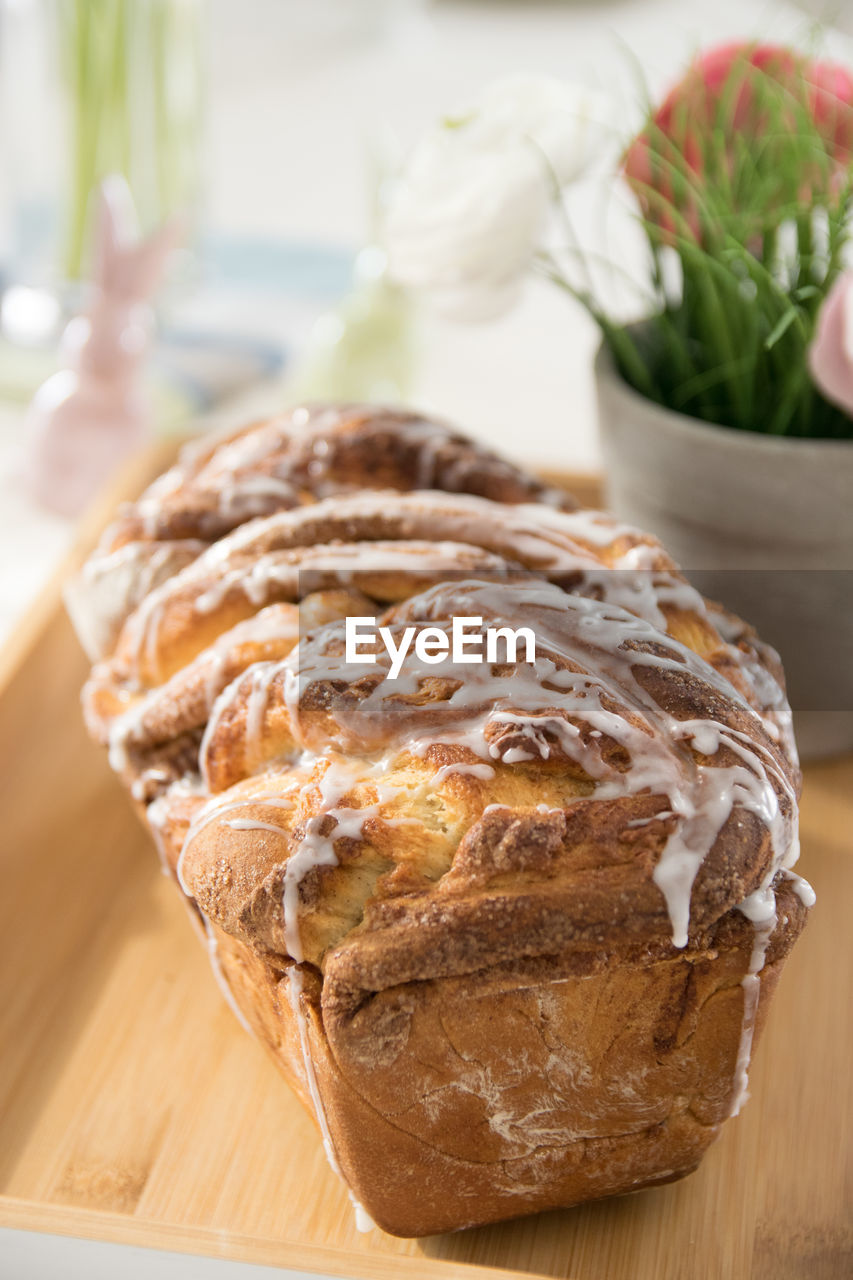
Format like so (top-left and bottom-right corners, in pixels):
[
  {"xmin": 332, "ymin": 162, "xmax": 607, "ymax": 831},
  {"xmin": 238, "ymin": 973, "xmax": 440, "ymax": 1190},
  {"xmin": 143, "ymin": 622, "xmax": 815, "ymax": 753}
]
[{"xmin": 596, "ymin": 347, "xmax": 853, "ymax": 759}]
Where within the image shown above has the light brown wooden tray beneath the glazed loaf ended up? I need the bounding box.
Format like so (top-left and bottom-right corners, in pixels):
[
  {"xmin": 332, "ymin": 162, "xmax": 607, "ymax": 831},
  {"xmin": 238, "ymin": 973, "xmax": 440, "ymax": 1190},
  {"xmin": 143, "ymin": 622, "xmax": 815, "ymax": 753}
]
[{"xmin": 0, "ymin": 458, "xmax": 853, "ymax": 1280}]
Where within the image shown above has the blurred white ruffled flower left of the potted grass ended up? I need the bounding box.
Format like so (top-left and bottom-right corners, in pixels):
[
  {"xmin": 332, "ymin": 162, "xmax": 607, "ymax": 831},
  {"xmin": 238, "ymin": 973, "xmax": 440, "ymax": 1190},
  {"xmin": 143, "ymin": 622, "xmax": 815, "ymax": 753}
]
[{"xmin": 386, "ymin": 76, "xmax": 606, "ymax": 320}]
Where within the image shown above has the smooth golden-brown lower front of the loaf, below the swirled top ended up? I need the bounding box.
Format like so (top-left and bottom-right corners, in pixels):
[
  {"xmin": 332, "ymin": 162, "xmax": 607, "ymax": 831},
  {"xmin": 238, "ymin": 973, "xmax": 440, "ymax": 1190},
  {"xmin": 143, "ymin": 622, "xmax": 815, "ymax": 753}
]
[{"xmin": 206, "ymin": 883, "xmax": 806, "ymax": 1235}]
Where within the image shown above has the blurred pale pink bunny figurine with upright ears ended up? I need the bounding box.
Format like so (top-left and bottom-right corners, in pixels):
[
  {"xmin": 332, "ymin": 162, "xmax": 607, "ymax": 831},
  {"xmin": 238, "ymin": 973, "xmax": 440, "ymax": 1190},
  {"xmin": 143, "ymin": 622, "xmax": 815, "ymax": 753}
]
[{"xmin": 27, "ymin": 177, "xmax": 179, "ymax": 516}]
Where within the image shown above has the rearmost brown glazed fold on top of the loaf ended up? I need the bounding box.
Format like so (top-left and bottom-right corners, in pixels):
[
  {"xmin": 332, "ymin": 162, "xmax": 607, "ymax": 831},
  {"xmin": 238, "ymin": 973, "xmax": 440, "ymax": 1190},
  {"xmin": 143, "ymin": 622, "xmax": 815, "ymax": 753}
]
[{"xmin": 78, "ymin": 404, "xmax": 575, "ymax": 660}]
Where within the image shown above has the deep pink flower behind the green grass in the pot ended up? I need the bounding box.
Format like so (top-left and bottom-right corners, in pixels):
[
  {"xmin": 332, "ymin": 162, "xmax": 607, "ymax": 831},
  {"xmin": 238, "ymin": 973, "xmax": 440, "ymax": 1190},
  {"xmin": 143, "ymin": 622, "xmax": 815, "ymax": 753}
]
[{"xmin": 625, "ymin": 42, "xmax": 853, "ymax": 238}]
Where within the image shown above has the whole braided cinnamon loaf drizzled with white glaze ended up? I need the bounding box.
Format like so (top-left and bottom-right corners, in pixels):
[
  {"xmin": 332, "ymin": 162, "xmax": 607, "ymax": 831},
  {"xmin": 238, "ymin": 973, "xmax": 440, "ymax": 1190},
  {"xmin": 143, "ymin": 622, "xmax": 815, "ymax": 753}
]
[{"xmin": 73, "ymin": 408, "xmax": 812, "ymax": 1235}]
